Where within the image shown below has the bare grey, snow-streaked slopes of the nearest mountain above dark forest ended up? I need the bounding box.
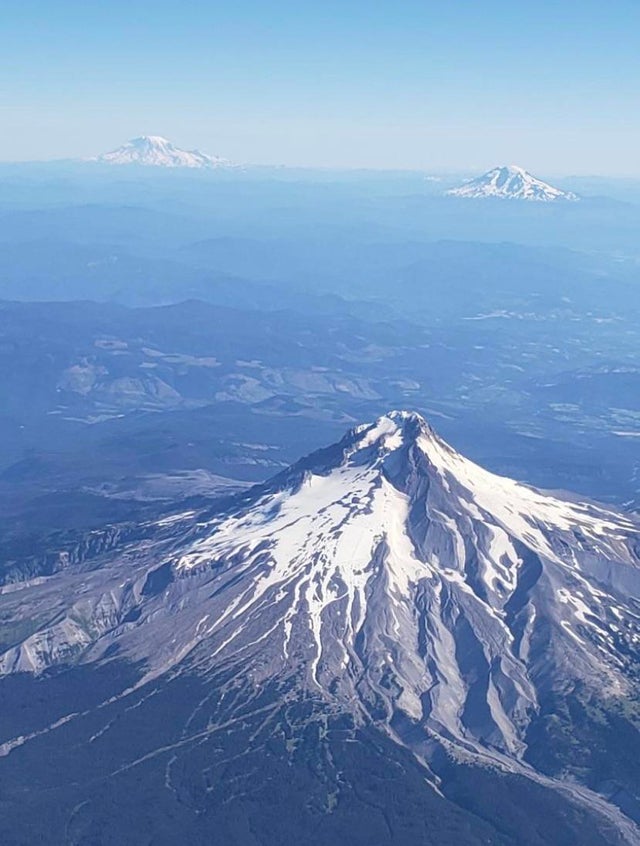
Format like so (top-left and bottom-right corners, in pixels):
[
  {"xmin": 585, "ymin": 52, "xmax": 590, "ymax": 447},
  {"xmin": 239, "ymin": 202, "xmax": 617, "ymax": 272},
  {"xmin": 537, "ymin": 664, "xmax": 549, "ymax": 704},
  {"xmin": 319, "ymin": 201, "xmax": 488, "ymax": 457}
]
[{"xmin": 0, "ymin": 412, "xmax": 640, "ymax": 844}]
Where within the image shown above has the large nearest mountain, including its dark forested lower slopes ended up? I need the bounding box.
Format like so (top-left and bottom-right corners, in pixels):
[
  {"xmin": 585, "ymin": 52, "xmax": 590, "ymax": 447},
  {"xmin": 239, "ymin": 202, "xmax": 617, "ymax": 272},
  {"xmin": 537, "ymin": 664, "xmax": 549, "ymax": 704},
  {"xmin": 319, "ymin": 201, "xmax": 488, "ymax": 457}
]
[{"xmin": 0, "ymin": 412, "xmax": 640, "ymax": 846}]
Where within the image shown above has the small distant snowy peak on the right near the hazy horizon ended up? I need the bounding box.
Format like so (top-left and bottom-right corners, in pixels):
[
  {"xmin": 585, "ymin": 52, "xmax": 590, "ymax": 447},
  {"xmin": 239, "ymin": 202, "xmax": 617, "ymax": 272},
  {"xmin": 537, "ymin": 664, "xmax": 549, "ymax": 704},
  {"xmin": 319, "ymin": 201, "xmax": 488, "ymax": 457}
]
[{"xmin": 447, "ymin": 165, "xmax": 580, "ymax": 203}]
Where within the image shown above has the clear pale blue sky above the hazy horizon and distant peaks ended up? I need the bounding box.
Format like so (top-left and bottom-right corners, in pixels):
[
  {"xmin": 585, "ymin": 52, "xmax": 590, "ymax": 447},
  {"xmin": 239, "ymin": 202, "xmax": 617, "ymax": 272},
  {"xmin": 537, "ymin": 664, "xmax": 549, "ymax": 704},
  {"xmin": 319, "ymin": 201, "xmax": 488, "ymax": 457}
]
[{"xmin": 0, "ymin": 0, "xmax": 640, "ymax": 176}]
